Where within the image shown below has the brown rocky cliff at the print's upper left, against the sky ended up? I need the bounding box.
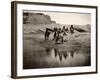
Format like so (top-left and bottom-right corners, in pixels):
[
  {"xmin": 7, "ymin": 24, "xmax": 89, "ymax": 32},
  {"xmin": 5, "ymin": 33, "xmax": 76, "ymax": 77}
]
[{"xmin": 23, "ymin": 13, "xmax": 56, "ymax": 24}]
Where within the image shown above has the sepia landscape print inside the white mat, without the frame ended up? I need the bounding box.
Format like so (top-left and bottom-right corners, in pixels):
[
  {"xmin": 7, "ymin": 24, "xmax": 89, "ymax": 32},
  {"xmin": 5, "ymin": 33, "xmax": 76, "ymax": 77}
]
[{"xmin": 23, "ymin": 10, "xmax": 91, "ymax": 69}]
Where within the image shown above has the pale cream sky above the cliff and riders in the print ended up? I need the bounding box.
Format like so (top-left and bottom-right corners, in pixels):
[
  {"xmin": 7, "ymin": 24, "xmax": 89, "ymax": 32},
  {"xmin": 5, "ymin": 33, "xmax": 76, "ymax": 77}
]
[{"xmin": 25, "ymin": 11, "xmax": 91, "ymax": 25}]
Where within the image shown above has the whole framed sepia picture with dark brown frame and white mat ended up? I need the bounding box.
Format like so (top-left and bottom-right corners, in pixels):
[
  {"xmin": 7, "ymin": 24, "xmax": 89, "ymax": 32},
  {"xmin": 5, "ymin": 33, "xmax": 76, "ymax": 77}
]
[{"xmin": 11, "ymin": 1, "xmax": 97, "ymax": 78}]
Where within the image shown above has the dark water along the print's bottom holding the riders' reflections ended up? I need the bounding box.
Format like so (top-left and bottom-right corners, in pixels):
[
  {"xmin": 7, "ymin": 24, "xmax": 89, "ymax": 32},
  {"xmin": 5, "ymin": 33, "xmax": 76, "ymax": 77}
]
[{"xmin": 23, "ymin": 48, "xmax": 91, "ymax": 69}]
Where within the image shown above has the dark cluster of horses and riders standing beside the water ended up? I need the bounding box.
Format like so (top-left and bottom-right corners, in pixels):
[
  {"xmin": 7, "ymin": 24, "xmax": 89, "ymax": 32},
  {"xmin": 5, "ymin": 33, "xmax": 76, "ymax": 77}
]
[{"xmin": 45, "ymin": 25, "xmax": 74, "ymax": 43}]
